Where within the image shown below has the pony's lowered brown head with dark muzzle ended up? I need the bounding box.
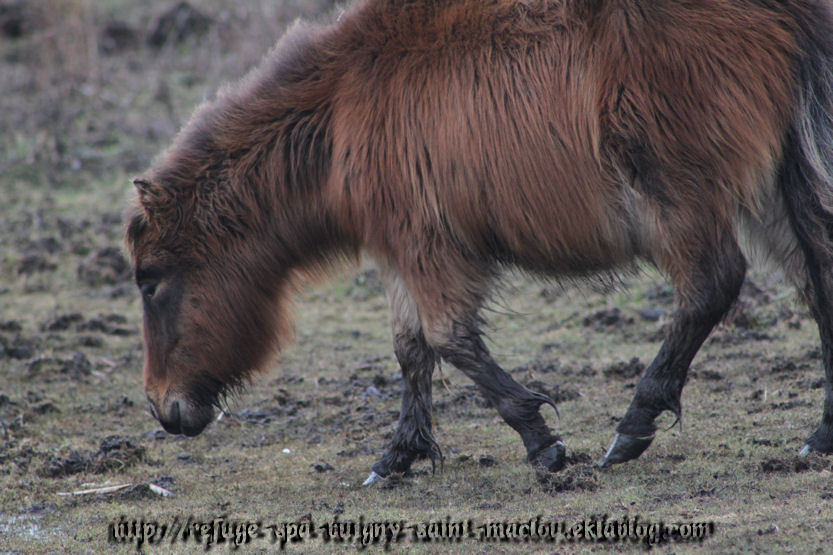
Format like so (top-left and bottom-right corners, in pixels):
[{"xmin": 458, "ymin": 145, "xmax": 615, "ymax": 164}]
[{"xmin": 125, "ymin": 165, "xmax": 289, "ymax": 436}]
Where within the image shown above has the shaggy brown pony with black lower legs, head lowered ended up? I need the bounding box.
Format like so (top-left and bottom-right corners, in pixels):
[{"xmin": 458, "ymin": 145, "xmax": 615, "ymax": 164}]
[{"xmin": 126, "ymin": 0, "xmax": 833, "ymax": 481}]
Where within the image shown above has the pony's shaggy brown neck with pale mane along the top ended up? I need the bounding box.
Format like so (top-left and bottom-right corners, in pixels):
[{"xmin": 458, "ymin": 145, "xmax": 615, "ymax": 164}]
[{"xmin": 200, "ymin": 21, "xmax": 356, "ymax": 267}]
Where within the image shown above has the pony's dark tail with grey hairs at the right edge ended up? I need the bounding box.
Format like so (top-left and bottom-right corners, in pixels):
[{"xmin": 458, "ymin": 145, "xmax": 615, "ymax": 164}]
[{"xmin": 781, "ymin": 0, "xmax": 833, "ymax": 215}]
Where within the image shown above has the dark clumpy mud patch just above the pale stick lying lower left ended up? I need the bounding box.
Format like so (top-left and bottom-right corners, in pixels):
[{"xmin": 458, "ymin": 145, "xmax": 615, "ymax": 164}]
[{"xmin": 37, "ymin": 436, "xmax": 145, "ymax": 478}]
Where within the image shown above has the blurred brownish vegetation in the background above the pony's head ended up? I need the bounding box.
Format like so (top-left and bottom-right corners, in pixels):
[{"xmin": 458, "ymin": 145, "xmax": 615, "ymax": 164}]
[{"xmin": 0, "ymin": 0, "xmax": 332, "ymax": 193}]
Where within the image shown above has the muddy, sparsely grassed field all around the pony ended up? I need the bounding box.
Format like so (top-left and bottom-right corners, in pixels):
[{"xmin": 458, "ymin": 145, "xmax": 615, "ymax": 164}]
[{"xmin": 0, "ymin": 0, "xmax": 833, "ymax": 553}]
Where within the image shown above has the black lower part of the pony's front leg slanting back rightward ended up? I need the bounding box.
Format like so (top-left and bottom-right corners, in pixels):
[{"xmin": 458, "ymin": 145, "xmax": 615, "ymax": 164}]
[{"xmin": 439, "ymin": 325, "xmax": 565, "ymax": 471}]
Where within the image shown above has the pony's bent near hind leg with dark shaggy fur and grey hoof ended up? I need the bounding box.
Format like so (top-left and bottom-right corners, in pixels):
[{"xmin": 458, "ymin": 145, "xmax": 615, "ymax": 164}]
[{"xmin": 602, "ymin": 220, "xmax": 746, "ymax": 466}]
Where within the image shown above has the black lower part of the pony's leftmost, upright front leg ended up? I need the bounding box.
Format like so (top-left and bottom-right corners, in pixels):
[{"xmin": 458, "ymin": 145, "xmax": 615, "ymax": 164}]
[{"xmin": 371, "ymin": 332, "xmax": 442, "ymax": 477}]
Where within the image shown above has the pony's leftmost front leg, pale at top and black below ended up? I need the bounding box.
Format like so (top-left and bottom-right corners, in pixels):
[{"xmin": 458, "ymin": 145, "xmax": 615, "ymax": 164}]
[{"xmin": 365, "ymin": 269, "xmax": 442, "ymax": 485}]
